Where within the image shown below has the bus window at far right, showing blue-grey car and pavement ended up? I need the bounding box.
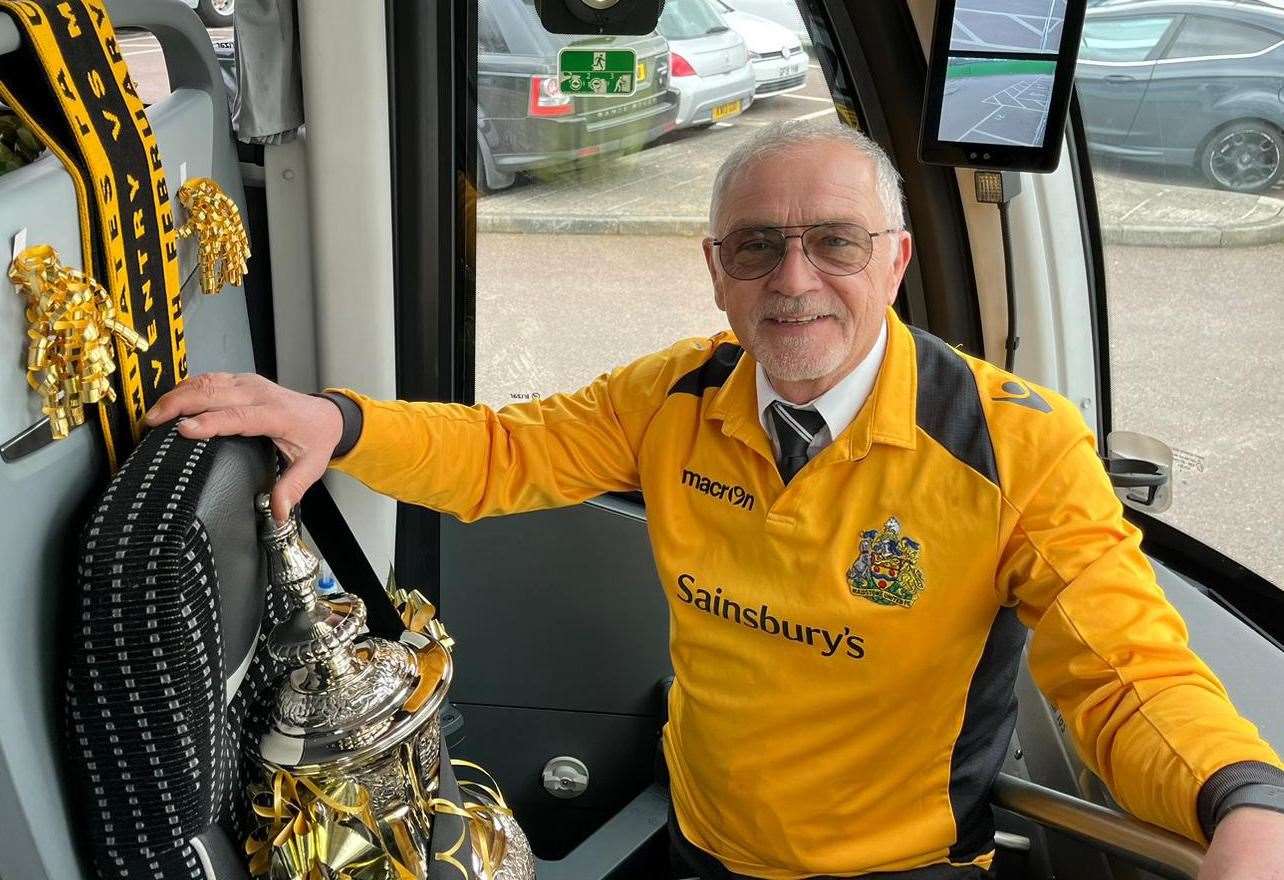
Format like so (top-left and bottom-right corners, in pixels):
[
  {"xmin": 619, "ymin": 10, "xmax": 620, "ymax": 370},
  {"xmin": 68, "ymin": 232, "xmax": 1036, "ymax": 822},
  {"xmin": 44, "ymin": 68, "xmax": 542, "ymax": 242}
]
[{"xmin": 1077, "ymin": 3, "xmax": 1284, "ymax": 586}]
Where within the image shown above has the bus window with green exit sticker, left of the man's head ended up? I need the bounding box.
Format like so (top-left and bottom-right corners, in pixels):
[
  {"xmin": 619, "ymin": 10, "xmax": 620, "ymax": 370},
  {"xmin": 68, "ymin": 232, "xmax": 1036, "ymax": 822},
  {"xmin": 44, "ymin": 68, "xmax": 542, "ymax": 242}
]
[{"xmin": 475, "ymin": 0, "xmax": 836, "ymax": 406}]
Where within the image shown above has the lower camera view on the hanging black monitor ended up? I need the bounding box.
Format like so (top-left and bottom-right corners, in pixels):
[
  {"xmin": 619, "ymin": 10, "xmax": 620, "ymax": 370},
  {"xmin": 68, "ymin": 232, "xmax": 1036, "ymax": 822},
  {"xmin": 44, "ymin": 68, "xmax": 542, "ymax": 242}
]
[{"xmin": 937, "ymin": 58, "xmax": 1057, "ymax": 146}]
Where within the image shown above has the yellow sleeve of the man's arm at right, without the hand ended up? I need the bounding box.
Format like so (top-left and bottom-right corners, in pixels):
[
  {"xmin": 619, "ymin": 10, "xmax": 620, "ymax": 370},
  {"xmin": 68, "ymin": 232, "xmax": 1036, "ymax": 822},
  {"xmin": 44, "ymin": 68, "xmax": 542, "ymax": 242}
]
[{"xmin": 999, "ymin": 429, "xmax": 1284, "ymax": 857}]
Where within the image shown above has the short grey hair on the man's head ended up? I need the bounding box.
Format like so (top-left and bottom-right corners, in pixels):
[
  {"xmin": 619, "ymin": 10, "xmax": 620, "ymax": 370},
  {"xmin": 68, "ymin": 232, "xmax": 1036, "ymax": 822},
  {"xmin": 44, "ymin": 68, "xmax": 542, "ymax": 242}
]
[{"xmin": 709, "ymin": 119, "xmax": 905, "ymax": 235}]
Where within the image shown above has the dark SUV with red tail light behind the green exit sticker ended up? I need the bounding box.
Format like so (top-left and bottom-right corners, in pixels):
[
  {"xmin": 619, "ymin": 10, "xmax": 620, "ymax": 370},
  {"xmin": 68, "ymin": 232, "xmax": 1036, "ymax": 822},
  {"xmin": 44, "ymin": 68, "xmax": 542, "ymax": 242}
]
[{"xmin": 476, "ymin": 0, "xmax": 678, "ymax": 190}]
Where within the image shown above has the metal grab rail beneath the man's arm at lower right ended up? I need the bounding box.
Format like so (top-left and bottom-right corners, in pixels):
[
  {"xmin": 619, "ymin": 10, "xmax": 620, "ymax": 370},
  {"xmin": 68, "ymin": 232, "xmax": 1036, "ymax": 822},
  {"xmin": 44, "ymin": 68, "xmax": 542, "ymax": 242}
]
[{"xmin": 991, "ymin": 773, "xmax": 1203, "ymax": 880}]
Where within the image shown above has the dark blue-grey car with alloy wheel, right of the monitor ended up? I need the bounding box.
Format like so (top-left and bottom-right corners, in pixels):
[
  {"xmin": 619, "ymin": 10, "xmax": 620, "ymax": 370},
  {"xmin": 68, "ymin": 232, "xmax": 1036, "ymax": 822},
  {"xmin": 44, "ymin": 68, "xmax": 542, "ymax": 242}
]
[{"xmin": 1076, "ymin": 0, "xmax": 1284, "ymax": 193}]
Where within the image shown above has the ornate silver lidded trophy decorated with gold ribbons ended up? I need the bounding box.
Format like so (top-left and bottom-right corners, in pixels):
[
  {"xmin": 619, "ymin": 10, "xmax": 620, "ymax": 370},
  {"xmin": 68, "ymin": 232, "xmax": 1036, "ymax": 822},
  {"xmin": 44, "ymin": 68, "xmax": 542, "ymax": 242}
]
[{"xmin": 247, "ymin": 495, "xmax": 534, "ymax": 880}]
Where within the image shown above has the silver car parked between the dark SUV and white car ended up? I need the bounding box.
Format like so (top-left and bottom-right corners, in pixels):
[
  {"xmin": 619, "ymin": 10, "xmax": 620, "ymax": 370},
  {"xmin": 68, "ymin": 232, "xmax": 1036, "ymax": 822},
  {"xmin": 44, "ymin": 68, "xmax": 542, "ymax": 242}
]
[{"xmin": 660, "ymin": 0, "xmax": 755, "ymax": 128}]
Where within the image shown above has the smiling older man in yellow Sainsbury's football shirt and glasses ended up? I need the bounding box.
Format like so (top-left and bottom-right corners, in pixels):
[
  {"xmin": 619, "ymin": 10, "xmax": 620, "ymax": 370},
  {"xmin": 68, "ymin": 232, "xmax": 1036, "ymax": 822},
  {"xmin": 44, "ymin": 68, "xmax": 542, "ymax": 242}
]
[{"xmin": 149, "ymin": 123, "xmax": 1284, "ymax": 880}]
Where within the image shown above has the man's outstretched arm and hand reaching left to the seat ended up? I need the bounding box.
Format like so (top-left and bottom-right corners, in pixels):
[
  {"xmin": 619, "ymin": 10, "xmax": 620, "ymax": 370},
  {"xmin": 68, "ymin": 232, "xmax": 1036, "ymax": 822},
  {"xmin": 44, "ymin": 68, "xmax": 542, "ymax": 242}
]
[{"xmin": 146, "ymin": 339, "xmax": 693, "ymax": 522}]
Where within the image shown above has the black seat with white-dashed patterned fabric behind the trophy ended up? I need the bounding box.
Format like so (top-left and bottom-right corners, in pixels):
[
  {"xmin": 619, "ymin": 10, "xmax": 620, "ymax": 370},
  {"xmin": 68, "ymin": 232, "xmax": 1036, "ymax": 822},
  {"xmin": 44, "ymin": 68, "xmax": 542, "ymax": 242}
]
[{"xmin": 65, "ymin": 425, "xmax": 286, "ymax": 880}]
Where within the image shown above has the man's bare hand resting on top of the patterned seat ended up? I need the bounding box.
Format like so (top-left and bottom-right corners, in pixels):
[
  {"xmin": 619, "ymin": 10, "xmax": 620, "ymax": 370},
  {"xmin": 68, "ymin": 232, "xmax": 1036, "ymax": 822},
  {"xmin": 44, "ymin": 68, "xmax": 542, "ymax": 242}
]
[{"xmin": 146, "ymin": 373, "xmax": 343, "ymax": 523}]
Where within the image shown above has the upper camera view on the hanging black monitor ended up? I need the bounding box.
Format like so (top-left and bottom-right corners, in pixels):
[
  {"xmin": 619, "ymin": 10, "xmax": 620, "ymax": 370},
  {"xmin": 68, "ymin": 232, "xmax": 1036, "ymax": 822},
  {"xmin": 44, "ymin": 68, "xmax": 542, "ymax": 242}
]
[{"xmin": 950, "ymin": 0, "xmax": 1066, "ymax": 55}]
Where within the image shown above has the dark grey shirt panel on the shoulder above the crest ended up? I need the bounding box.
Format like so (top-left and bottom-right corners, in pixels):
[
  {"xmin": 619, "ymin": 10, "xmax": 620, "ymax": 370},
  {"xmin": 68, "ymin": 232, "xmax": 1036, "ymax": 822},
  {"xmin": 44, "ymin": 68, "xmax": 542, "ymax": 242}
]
[{"xmin": 909, "ymin": 328, "xmax": 999, "ymax": 486}]
